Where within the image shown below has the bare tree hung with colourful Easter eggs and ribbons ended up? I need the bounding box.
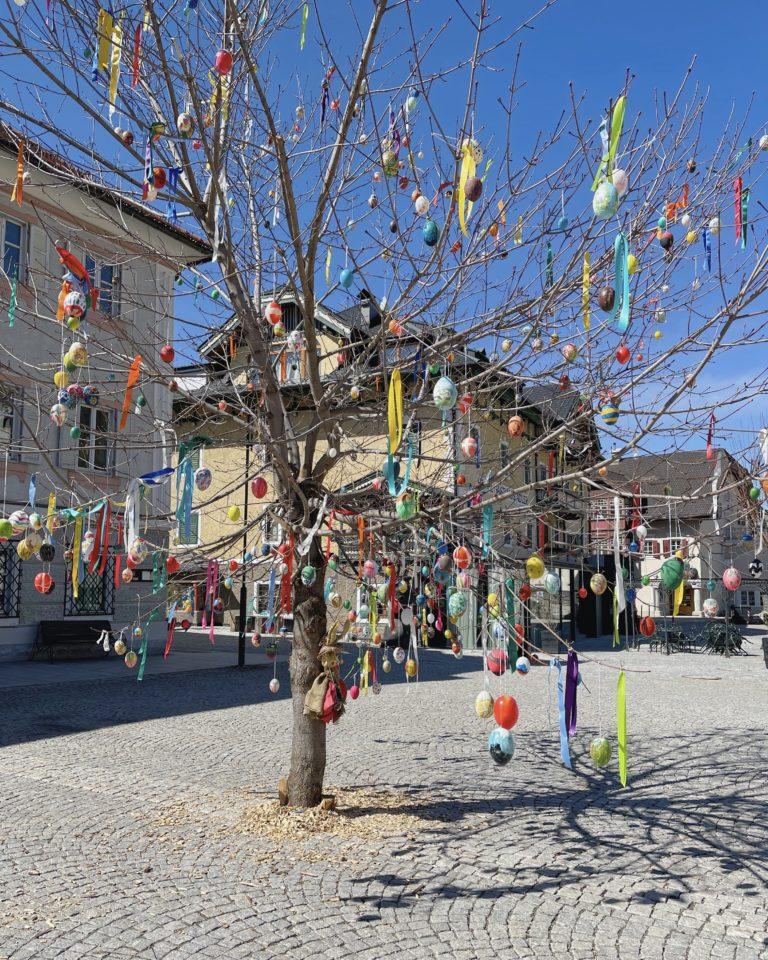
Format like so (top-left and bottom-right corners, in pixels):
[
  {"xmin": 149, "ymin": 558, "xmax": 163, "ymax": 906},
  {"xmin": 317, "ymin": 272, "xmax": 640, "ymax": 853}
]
[{"xmin": 0, "ymin": 0, "xmax": 768, "ymax": 805}]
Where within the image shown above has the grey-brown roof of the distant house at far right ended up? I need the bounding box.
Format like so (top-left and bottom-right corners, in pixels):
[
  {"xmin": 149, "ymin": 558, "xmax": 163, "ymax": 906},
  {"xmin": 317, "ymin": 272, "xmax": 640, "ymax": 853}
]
[{"xmin": 606, "ymin": 447, "xmax": 749, "ymax": 521}]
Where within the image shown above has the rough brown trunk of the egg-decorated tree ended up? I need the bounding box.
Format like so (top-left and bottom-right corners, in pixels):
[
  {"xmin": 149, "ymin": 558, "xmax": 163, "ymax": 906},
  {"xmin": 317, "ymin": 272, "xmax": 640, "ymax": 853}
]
[{"xmin": 288, "ymin": 540, "xmax": 326, "ymax": 807}]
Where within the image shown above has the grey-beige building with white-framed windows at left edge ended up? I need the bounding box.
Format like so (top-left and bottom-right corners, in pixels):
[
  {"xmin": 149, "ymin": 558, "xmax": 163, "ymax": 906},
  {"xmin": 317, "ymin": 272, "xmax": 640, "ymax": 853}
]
[{"xmin": 0, "ymin": 125, "xmax": 210, "ymax": 659}]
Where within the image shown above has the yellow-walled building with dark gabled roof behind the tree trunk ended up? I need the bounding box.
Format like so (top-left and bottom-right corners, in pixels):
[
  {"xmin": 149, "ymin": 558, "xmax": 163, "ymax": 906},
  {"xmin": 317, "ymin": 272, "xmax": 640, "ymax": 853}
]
[{"xmin": 172, "ymin": 291, "xmax": 597, "ymax": 644}]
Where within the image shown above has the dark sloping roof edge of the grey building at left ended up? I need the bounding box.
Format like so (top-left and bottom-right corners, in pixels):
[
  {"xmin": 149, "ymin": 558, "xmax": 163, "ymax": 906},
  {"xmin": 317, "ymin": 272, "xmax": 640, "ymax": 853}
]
[{"xmin": 0, "ymin": 121, "xmax": 213, "ymax": 264}]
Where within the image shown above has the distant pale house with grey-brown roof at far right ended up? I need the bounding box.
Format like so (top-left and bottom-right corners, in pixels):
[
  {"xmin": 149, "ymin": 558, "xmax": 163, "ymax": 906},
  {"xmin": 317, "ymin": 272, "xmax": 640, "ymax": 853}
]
[{"xmin": 590, "ymin": 448, "xmax": 768, "ymax": 616}]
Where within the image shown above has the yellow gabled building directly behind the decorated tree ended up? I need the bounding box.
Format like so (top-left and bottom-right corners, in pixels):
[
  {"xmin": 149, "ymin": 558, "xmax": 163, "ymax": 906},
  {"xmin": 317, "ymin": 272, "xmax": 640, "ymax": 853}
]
[{"xmin": 174, "ymin": 291, "xmax": 599, "ymax": 636}]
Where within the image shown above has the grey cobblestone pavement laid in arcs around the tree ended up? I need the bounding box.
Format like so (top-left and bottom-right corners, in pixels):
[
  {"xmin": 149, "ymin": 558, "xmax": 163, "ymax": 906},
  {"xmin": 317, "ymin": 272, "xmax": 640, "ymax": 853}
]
[{"xmin": 0, "ymin": 652, "xmax": 768, "ymax": 960}]
